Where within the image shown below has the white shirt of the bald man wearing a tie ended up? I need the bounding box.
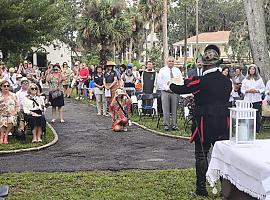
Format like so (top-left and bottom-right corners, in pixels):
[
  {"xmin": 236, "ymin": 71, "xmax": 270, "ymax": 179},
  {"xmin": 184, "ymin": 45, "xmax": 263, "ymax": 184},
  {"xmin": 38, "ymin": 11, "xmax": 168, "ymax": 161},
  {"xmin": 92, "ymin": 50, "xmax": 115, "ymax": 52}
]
[{"xmin": 157, "ymin": 66, "xmax": 182, "ymax": 91}]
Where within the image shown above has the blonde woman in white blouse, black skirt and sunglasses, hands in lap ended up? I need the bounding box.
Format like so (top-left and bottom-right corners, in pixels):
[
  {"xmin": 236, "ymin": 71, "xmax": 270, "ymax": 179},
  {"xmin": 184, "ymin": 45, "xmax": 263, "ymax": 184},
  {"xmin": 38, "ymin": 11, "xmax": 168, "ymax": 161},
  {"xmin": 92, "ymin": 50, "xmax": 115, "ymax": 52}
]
[{"xmin": 22, "ymin": 83, "xmax": 46, "ymax": 142}]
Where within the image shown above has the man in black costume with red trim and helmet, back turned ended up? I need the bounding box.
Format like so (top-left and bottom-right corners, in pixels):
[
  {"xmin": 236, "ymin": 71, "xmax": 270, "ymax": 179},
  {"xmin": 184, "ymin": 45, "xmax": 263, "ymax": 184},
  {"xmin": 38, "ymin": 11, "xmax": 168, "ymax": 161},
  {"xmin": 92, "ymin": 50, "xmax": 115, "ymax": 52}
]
[{"xmin": 170, "ymin": 45, "xmax": 232, "ymax": 196}]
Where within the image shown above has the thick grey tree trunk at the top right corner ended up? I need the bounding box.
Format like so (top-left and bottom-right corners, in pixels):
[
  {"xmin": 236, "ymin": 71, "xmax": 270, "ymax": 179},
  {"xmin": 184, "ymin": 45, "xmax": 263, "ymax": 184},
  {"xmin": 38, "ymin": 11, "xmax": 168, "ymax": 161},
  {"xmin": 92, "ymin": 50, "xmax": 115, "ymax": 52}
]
[{"xmin": 244, "ymin": 0, "xmax": 270, "ymax": 80}]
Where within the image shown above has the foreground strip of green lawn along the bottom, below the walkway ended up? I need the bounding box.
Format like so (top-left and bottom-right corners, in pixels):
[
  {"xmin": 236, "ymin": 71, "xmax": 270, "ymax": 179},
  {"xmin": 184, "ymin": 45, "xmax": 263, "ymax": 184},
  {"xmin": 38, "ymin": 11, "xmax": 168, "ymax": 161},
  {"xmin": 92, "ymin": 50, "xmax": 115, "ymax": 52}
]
[{"xmin": 0, "ymin": 169, "xmax": 221, "ymax": 200}]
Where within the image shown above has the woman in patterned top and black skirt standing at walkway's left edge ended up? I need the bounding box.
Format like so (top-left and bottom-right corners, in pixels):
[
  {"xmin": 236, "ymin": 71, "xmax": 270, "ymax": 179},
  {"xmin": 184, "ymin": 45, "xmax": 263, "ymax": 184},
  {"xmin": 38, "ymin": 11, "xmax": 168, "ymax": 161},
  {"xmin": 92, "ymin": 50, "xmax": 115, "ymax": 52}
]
[{"xmin": 47, "ymin": 65, "xmax": 66, "ymax": 123}]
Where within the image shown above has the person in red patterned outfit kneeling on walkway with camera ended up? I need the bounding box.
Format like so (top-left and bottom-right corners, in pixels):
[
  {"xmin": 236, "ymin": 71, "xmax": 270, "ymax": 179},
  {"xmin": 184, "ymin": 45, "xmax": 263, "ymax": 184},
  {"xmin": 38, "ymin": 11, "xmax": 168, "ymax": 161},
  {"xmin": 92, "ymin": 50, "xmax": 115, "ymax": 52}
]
[{"xmin": 110, "ymin": 89, "xmax": 132, "ymax": 132}]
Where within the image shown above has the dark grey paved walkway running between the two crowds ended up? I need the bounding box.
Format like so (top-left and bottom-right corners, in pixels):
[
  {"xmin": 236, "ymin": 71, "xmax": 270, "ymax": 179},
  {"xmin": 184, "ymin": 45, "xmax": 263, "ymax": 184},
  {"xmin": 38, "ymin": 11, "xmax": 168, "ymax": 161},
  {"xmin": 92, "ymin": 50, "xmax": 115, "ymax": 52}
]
[{"xmin": 0, "ymin": 99, "xmax": 194, "ymax": 172}]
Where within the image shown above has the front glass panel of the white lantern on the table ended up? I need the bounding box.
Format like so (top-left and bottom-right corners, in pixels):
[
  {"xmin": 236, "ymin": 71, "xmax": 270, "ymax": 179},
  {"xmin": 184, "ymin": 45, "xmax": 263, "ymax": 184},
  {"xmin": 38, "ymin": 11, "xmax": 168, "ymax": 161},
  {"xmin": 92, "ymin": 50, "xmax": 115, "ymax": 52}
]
[{"xmin": 238, "ymin": 119, "xmax": 254, "ymax": 142}]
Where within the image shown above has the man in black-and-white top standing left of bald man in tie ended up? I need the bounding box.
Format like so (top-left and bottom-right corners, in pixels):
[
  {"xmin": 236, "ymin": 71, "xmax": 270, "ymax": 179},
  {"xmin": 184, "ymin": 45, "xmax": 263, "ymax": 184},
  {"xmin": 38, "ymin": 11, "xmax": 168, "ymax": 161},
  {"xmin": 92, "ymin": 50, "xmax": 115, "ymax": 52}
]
[{"xmin": 142, "ymin": 61, "xmax": 157, "ymax": 94}]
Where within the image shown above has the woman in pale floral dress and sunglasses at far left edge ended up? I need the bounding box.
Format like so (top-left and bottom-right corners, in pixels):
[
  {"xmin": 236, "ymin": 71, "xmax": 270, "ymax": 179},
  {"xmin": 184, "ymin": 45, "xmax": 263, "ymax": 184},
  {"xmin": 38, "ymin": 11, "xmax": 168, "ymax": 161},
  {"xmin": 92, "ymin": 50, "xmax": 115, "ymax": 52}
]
[{"xmin": 0, "ymin": 80, "xmax": 20, "ymax": 144}]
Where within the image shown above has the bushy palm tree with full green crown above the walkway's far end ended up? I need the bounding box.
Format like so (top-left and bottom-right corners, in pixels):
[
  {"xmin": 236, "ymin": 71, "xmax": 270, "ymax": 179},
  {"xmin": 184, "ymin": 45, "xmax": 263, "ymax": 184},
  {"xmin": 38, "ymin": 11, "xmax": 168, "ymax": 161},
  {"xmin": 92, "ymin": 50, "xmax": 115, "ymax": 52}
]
[{"xmin": 79, "ymin": 0, "xmax": 132, "ymax": 65}]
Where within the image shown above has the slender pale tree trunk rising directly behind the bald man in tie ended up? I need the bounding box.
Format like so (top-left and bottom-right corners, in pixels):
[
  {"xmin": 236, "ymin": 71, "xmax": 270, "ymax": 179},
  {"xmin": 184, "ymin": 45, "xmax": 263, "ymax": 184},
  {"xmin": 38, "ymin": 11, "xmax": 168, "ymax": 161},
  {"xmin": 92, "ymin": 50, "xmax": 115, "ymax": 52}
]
[{"xmin": 162, "ymin": 0, "xmax": 169, "ymax": 65}]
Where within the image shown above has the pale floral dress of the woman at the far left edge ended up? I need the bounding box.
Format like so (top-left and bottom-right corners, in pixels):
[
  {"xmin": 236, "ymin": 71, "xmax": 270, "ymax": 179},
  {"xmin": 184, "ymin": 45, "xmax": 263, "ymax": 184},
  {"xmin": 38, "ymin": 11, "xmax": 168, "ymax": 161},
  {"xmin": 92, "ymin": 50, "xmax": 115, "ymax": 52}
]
[{"xmin": 0, "ymin": 92, "xmax": 20, "ymax": 127}]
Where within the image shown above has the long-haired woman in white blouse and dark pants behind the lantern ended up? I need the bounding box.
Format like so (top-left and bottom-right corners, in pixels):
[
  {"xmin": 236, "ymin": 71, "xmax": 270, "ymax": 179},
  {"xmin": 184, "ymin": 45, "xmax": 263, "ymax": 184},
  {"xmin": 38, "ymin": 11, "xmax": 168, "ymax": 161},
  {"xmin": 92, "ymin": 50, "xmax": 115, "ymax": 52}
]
[{"xmin": 241, "ymin": 64, "xmax": 265, "ymax": 133}]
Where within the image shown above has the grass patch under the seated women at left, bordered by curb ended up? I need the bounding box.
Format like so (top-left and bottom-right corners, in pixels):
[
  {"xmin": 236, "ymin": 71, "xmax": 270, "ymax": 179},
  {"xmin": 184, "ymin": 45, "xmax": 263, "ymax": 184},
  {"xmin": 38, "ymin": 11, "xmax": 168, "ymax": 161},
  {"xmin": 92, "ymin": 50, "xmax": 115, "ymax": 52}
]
[{"xmin": 0, "ymin": 126, "xmax": 54, "ymax": 151}]
